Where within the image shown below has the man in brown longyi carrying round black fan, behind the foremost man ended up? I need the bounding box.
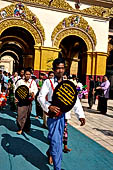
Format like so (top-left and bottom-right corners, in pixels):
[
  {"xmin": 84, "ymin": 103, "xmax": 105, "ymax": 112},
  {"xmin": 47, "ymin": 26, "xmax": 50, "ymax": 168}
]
[{"xmin": 15, "ymin": 69, "xmax": 38, "ymax": 135}]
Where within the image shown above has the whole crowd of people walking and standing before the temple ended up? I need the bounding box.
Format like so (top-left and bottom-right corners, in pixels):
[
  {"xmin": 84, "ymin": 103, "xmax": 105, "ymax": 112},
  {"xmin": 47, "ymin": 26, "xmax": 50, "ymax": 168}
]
[{"xmin": 0, "ymin": 58, "xmax": 110, "ymax": 170}]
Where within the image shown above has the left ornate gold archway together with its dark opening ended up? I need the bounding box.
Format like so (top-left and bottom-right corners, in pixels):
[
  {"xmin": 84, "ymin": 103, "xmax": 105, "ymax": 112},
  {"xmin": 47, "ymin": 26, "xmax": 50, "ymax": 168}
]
[{"xmin": 0, "ymin": 3, "xmax": 45, "ymax": 69}]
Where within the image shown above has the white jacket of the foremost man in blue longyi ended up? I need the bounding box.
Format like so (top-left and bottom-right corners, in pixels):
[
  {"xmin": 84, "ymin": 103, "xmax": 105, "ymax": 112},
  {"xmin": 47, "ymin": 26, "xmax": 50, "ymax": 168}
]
[{"xmin": 38, "ymin": 78, "xmax": 85, "ymax": 118}]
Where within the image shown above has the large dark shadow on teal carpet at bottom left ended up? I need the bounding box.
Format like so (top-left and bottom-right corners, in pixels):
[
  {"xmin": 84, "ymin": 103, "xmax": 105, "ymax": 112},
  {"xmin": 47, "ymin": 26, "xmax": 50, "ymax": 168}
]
[{"xmin": 1, "ymin": 134, "xmax": 49, "ymax": 170}]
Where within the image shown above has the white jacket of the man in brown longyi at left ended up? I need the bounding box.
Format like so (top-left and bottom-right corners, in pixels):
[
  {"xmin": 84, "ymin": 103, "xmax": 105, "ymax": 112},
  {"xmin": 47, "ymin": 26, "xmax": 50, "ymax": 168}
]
[{"xmin": 15, "ymin": 79, "xmax": 38, "ymax": 95}]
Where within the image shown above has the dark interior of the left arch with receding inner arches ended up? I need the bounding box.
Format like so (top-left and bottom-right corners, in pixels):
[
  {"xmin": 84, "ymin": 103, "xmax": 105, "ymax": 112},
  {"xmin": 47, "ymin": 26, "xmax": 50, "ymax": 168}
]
[{"xmin": 0, "ymin": 27, "xmax": 35, "ymax": 71}]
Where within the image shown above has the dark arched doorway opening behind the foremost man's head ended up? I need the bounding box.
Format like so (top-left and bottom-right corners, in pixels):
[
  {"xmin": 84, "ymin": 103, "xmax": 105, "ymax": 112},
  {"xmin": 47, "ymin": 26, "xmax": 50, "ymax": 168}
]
[{"xmin": 59, "ymin": 35, "xmax": 87, "ymax": 82}]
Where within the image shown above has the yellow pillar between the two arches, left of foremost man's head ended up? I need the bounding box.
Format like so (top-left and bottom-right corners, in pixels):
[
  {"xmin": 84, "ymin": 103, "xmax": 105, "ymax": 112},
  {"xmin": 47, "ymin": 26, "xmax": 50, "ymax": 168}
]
[{"xmin": 34, "ymin": 46, "xmax": 60, "ymax": 71}]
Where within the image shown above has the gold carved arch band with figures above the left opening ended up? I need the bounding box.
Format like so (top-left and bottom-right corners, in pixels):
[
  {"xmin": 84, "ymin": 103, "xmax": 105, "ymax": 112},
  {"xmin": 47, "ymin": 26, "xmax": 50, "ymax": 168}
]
[{"xmin": 0, "ymin": 3, "xmax": 45, "ymax": 41}]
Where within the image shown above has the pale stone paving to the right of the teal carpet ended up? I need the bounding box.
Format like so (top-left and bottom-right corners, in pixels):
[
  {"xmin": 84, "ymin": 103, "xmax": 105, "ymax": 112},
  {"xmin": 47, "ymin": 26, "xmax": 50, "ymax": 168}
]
[{"xmin": 69, "ymin": 99, "xmax": 113, "ymax": 153}]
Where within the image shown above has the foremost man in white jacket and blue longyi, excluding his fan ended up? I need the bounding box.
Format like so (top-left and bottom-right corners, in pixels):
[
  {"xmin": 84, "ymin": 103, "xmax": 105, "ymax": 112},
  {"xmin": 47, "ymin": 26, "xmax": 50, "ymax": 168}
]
[{"xmin": 38, "ymin": 58, "xmax": 85, "ymax": 170}]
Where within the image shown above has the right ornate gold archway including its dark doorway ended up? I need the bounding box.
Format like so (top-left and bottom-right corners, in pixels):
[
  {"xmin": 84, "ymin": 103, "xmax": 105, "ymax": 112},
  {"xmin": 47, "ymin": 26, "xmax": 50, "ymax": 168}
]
[{"xmin": 51, "ymin": 15, "xmax": 96, "ymax": 82}]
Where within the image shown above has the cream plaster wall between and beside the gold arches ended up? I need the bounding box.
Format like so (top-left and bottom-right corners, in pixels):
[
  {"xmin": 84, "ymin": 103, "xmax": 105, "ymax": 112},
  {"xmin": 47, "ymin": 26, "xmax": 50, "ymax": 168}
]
[{"xmin": 0, "ymin": 1, "xmax": 109, "ymax": 52}]
